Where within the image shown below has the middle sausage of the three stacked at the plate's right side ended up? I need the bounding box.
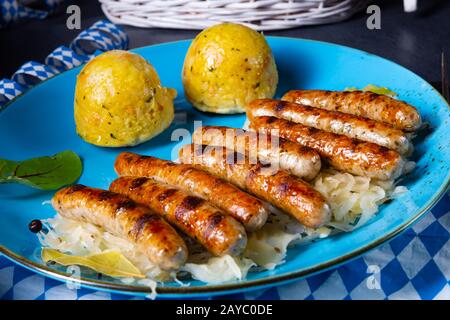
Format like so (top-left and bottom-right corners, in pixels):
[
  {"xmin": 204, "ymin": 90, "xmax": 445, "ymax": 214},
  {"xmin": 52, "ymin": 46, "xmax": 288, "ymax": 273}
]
[{"xmin": 247, "ymin": 99, "xmax": 413, "ymax": 155}]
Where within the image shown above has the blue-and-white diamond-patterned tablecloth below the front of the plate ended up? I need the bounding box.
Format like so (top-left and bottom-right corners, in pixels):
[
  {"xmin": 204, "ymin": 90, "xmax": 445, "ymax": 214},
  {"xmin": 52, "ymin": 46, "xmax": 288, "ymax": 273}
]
[{"xmin": 0, "ymin": 193, "xmax": 450, "ymax": 300}]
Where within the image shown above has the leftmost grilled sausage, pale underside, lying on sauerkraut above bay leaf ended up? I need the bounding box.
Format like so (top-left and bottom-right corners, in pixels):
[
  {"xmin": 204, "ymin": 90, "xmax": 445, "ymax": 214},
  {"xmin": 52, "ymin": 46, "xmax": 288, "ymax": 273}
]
[{"xmin": 52, "ymin": 184, "xmax": 188, "ymax": 270}]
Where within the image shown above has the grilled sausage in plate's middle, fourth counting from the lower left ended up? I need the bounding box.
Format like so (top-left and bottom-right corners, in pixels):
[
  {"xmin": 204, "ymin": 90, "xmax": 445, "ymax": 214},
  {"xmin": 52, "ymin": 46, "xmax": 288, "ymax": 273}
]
[{"xmin": 179, "ymin": 144, "xmax": 331, "ymax": 228}]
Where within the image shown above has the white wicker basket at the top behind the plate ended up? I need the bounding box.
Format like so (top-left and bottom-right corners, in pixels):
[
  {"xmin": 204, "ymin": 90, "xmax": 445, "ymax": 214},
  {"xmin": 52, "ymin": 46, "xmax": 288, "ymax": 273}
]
[{"xmin": 100, "ymin": 0, "xmax": 367, "ymax": 30}]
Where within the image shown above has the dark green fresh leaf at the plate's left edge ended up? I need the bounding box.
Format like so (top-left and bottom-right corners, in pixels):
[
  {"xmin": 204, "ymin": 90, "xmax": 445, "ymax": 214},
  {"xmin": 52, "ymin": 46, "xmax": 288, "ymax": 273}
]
[{"xmin": 0, "ymin": 151, "xmax": 82, "ymax": 190}]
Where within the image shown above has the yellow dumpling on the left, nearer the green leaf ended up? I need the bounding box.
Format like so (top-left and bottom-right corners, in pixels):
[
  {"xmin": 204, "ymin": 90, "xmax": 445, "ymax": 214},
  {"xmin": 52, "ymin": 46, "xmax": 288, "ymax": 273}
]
[{"xmin": 74, "ymin": 50, "xmax": 176, "ymax": 147}]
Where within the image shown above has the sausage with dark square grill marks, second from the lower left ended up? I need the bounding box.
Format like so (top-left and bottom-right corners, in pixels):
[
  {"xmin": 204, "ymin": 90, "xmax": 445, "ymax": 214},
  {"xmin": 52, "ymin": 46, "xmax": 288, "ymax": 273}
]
[{"xmin": 109, "ymin": 177, "xmax": 247, "ymax": 256}]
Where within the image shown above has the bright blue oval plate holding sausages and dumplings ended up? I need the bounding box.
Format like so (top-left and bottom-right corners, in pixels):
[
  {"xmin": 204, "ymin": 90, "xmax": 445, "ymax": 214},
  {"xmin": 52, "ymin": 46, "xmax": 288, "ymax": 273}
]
[{"xmin": 0, "ymin": 37, "xmax": 450, "ymax": 297}]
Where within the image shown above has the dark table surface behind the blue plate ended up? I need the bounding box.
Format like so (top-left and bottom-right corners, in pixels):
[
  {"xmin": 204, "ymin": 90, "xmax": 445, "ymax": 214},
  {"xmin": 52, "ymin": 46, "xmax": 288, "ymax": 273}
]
[{"xmin": 0, "ymin": 0, "xmax": 450, "ymax": 89}]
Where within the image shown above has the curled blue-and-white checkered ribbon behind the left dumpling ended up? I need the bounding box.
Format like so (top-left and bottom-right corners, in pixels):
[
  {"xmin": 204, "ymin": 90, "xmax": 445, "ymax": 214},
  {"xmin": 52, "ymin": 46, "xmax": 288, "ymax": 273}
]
[{"xmin": 0, "ymin": 19, "xmax": 128, "ymax": 109}]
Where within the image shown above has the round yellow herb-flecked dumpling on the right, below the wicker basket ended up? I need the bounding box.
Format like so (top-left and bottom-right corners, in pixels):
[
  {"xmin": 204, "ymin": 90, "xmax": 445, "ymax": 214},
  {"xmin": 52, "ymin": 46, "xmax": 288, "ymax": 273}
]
[{"xmin": 182, "ymin": 23, "xmax": 278, "ymax": 113}]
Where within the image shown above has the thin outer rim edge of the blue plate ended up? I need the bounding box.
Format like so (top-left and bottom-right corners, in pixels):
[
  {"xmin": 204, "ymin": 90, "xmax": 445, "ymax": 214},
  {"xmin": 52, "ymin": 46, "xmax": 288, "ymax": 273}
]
[{"xmin": 0, "ymin": 36, "xmax": 450, "ymax": 297}]
